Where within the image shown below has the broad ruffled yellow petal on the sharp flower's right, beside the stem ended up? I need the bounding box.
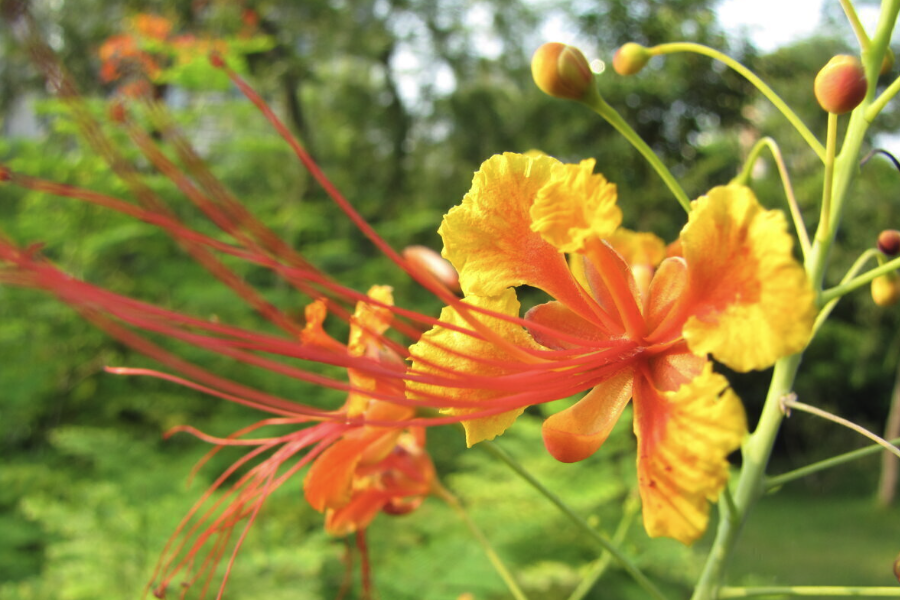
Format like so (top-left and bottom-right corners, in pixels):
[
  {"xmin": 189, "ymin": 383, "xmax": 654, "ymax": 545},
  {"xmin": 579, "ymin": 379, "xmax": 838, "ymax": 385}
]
[{"xmin": 681, "ymin": 185, "xmax": 815, "ymax": 371}]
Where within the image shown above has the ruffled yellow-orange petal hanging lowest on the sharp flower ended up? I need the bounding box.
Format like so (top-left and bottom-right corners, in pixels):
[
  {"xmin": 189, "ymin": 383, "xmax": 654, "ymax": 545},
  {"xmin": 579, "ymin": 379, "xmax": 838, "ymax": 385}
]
[{"xmin": 634, "ymin": 363, "xmax": 747, "ymax": 544}]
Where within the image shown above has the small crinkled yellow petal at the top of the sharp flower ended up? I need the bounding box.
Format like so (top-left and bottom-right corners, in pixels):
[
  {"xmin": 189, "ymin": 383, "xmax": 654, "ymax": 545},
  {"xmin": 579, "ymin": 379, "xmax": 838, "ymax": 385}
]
[{"xmin": 531, "ymin": 158, "xmax": 622, "ymax": 252}]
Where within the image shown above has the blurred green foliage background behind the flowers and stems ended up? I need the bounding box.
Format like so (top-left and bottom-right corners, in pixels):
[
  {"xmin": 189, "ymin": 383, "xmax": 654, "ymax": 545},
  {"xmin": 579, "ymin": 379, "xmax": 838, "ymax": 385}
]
[{"xmin": 0, "ymin": 0, "xmax": 900, "ymax": 600}]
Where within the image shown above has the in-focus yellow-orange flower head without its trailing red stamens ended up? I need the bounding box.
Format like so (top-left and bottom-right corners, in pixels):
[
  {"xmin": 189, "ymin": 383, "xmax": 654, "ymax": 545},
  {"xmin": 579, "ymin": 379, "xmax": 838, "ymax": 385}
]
[{"xmin": 408, "ymin": 154, "xmax": 814, "ymax": 543}]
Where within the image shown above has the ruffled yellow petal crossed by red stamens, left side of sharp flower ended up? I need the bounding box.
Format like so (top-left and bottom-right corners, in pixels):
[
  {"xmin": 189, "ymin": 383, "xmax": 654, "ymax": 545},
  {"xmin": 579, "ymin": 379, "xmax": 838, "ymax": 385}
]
[{"xmin": 407, "ymin": 290, "xmax": 540, "ymax": 447}]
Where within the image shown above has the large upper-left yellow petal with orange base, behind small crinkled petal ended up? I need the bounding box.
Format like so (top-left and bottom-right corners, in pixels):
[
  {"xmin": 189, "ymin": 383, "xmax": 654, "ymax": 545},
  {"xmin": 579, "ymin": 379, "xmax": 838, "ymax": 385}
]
[{"xmin": 438, "ymin": 153, "xmax": 590, "ymax": 314}]
